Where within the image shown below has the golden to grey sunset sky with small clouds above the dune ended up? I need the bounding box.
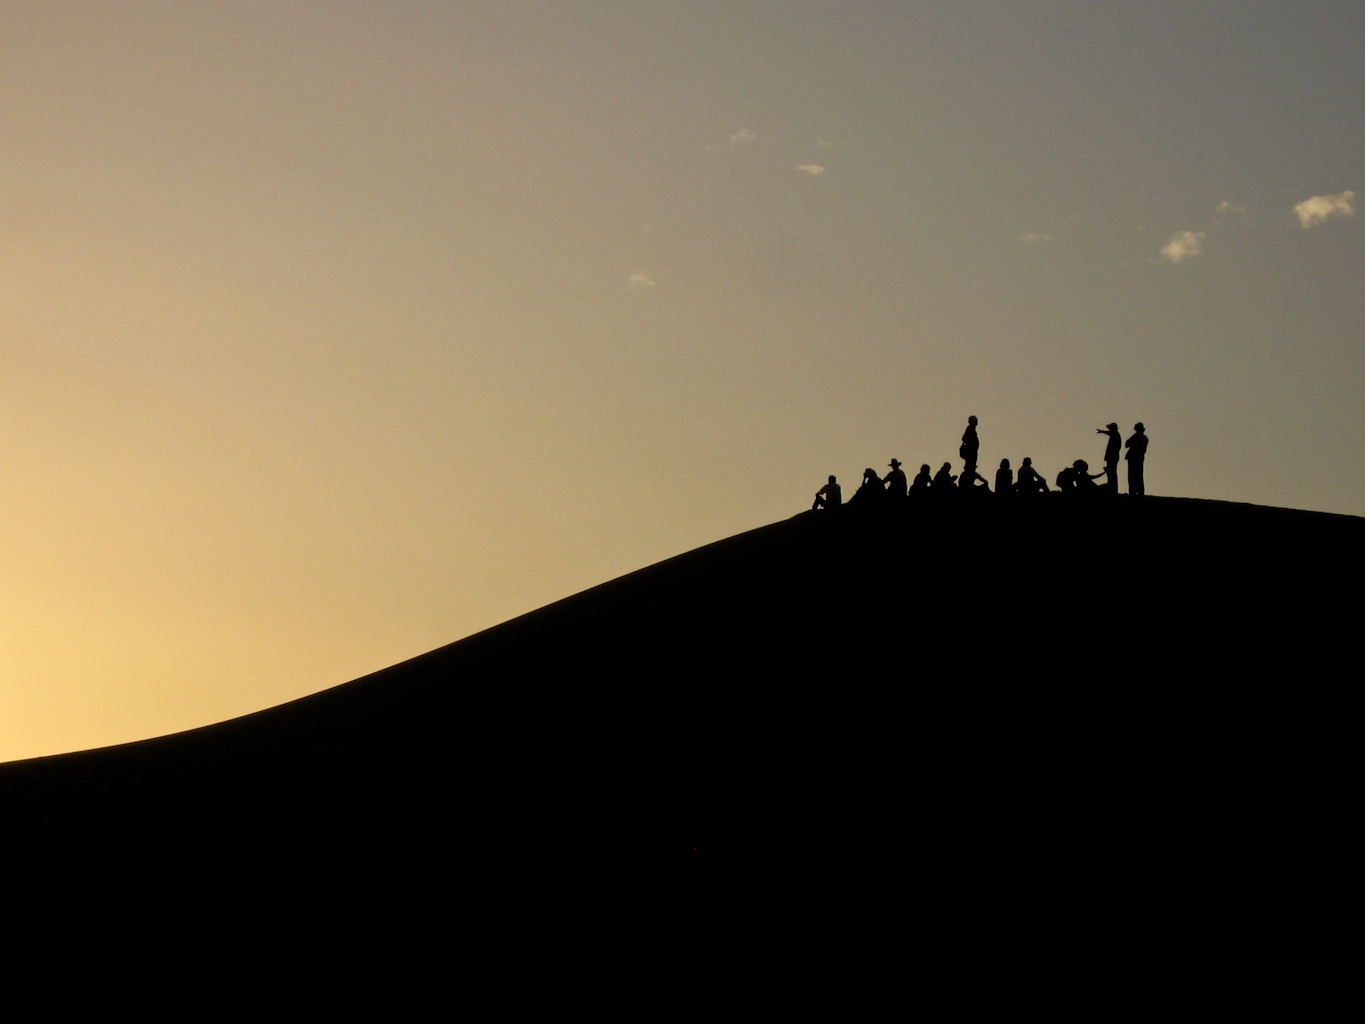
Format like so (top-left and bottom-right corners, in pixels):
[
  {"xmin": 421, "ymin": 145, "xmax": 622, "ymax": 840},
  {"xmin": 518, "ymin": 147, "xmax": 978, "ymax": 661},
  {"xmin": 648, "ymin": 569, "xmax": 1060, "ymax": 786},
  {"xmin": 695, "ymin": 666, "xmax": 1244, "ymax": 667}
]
[{"xmin": 0, "ymin": 0, "xmax": 1365, "ymax": 759}]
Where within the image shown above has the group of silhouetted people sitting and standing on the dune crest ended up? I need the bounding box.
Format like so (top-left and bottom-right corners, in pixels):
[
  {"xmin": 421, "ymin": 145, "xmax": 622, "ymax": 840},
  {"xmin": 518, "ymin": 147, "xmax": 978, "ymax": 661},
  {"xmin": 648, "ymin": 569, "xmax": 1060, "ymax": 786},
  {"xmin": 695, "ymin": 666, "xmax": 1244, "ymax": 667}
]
[{"xmin": 811, "ymin": 416, "xmax": 1147, "ymax": 511}]
